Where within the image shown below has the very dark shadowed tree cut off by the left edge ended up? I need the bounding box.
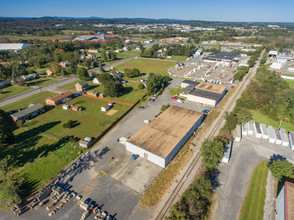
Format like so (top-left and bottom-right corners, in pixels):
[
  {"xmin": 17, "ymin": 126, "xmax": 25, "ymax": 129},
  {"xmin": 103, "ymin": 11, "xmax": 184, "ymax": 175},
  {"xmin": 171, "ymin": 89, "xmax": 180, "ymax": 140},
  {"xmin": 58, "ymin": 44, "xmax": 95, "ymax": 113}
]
[{"xmin": 0, "ymin": 109, "xmax": 15, "ymax": 146}]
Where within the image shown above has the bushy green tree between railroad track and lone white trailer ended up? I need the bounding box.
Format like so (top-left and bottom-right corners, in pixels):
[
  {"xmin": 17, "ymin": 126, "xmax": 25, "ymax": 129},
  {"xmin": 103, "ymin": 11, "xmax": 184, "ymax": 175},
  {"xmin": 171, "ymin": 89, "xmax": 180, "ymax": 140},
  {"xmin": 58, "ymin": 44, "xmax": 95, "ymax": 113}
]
[{"xmin": 200, "ymin": 137, "xmax": 227, "ymax": 170}]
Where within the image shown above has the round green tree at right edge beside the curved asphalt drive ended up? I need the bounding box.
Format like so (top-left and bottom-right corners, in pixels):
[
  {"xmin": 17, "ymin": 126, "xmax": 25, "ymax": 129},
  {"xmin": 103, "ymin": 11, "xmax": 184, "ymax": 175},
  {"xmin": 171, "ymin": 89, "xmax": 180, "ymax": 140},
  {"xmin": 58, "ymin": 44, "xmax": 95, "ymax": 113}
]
[{"xmin": 269, "ymin": 159, "xmax": 294, "ymax": 180}]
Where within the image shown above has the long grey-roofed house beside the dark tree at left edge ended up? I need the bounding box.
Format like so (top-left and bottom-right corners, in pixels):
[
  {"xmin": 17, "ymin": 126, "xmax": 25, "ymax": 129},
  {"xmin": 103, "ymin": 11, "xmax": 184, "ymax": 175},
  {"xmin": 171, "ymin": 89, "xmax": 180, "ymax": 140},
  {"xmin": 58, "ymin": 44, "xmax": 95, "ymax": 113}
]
[{"xmin": 11, "ymin": 103, "xmax": 45, "ymax": 121}]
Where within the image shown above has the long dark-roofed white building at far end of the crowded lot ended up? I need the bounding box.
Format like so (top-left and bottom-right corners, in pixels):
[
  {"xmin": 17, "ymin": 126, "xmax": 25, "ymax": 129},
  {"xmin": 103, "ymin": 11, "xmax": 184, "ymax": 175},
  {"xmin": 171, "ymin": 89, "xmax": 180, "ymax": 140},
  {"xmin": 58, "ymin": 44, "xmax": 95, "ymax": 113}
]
[{"xmin": 203, "ymin": 52, "xmax": 241, "ymax": 64}]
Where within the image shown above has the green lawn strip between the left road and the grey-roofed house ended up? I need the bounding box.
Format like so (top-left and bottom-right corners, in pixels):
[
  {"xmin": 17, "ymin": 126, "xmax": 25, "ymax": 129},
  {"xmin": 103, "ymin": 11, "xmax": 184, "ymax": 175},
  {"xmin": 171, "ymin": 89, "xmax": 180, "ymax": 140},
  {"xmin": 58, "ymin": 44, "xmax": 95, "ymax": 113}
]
[{"xmin": 0, "ymin": 92, "xmax": 57, "ymax": 111}]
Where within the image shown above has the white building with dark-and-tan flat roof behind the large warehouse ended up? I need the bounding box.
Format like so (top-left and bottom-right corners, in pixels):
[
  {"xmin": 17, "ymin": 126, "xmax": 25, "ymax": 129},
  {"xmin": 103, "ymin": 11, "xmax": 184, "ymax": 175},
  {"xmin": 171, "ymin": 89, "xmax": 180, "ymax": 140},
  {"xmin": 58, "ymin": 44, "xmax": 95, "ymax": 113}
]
[{"xmin": 180, "ymin": 80, "xmax": 226, "ymax": 106}]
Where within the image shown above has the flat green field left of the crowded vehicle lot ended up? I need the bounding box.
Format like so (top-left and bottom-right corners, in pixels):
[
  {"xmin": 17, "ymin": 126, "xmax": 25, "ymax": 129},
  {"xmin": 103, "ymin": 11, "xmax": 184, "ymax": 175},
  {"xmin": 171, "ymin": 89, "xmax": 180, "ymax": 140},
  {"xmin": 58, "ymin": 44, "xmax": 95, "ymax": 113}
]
[{"xmin": 115, "ymin": 59, "xmax": 175, "ymax": 75}]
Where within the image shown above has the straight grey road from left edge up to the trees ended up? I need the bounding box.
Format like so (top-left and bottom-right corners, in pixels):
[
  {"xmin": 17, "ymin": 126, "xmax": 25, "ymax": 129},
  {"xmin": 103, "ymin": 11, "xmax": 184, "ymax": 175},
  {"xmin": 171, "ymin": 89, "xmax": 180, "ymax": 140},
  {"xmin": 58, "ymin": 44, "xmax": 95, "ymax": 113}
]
[{"xmin": 0, "ymin": 76, "xmax": 77, "ymax": 106}]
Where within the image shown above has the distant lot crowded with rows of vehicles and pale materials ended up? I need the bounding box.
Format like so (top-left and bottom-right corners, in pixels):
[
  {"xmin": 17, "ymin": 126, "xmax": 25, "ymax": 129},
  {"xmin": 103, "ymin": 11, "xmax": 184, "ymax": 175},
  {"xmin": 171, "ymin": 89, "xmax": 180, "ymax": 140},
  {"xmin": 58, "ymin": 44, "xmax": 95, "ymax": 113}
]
[{"xmin": 169, "ymin": 53, "xmax": 250, "ymax": 84}]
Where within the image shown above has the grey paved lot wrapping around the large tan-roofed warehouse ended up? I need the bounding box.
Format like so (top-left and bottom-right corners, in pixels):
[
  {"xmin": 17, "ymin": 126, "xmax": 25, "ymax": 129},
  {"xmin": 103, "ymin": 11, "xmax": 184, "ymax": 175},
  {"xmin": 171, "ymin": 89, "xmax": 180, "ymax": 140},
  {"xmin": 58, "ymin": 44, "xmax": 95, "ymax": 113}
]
[{"xmin": 0, "ymin": 79, "xmax": 207, "ymax": 220}]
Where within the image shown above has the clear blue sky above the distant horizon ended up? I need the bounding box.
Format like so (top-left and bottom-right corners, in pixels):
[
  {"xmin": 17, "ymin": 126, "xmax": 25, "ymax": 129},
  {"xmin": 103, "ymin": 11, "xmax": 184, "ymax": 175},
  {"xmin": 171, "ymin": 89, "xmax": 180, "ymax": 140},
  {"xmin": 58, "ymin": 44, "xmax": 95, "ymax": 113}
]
[{"xmin": 0, "ymin": 0, "xmax": 294, "ymax": 22}]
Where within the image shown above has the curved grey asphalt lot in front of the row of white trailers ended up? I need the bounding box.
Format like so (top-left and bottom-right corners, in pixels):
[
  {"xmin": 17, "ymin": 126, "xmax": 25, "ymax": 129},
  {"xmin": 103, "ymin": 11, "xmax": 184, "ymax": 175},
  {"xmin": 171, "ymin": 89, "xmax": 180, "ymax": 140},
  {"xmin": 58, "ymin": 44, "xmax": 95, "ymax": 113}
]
[{"xmin": 215, "ymin": 135, "xmax": 294, "ymax": 220}]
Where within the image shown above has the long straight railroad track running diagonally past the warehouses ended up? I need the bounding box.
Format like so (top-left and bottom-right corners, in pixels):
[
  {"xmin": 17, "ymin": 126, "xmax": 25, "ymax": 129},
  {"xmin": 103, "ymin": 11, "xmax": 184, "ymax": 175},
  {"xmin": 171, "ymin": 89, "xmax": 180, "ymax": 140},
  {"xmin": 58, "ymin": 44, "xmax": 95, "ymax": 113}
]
[{"xmin": 155, "ymin": 51, "xmax": 265, "ymax": 220}]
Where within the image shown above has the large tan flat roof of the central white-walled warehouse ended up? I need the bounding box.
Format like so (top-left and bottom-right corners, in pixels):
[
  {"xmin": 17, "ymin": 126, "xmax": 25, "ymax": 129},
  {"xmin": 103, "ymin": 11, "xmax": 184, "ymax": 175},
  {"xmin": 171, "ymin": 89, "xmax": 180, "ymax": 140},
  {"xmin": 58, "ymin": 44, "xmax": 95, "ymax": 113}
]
[{"xmin": 128, "ymin": 106, "xmax": 202, "ymax": 158}]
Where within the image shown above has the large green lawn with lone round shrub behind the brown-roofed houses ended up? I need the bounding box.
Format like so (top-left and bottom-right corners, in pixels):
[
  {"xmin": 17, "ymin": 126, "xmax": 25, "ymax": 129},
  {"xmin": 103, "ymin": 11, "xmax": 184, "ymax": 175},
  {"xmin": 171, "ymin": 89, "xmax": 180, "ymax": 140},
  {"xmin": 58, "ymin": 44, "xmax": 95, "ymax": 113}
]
[{"xmin": 25, "ymin": 96, "xmax": 130, "ymax": 139}]
